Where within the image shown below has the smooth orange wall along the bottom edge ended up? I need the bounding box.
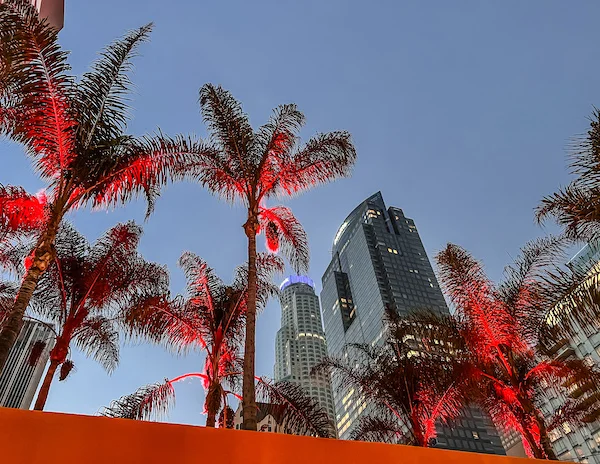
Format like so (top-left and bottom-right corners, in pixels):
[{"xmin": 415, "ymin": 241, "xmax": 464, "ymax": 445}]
[{"xmin": 0, "ymin": 408, "xmax": 542, "ymax": 464}]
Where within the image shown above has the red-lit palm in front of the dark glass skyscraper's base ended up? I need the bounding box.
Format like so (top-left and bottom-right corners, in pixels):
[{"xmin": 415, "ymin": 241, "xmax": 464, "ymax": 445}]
[{"xmin": 313, "ymin": 308, "xmax": 465, "ymax": 447}]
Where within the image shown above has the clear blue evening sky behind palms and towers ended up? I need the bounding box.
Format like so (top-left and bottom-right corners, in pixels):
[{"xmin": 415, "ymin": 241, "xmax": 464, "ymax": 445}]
[{"xmin": 0, "ymin": 0, "xmax": 600, "ymax": 424}]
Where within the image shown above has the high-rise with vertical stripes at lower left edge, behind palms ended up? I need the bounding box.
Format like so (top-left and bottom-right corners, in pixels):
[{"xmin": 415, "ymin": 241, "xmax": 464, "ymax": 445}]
[{"xmin": 0, "ymin": 321, "xmax": 51, "ymax": 409}]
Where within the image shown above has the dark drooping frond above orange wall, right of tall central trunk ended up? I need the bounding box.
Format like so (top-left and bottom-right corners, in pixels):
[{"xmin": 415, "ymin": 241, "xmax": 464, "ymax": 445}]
[{"xmin": 257, "ymin": 378, "xmax": 334, "ymax": 438}]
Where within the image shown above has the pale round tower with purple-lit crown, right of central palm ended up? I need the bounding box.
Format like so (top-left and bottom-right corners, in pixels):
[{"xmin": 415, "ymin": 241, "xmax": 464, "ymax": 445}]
[{"xmin": 274, "ymin": 276, "xmax": 335, "ymax": 432}]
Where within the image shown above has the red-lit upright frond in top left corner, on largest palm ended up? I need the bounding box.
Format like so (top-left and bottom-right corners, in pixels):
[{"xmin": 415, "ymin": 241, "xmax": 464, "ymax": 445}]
[{"xmin": 0, "ymin": 0, "xmax": 76, "ymax": 178}]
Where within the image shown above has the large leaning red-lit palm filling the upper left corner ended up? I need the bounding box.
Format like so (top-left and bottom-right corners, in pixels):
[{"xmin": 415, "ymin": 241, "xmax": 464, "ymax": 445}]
[{"xmin": 0, "ymin": 0, "xmax": 204, "ymax": 369}]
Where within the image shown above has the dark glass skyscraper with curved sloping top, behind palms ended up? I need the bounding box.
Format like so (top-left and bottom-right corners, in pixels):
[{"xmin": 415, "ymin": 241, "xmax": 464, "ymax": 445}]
[{"xmin": 321, "ymin": 192, "xmax": 504, "ymax": 454}]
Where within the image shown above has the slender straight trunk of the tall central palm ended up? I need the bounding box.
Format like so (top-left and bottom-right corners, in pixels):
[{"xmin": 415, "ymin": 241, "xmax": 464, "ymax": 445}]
[{"xmin": 242, "ymin": 212, "xmax": 258, "ymax": 430}]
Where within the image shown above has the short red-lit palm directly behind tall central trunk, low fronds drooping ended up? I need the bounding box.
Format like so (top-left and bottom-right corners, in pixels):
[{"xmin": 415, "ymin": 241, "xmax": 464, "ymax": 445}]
[{"xmin": 103, "ymin": 252, "xmax": 328, "ymax": 436}]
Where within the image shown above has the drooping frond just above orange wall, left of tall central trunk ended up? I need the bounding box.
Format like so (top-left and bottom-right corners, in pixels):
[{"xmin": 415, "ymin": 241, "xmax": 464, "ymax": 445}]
[{"xmin": 99, "ymin": 380, "xmax": 175, "ymax": 420}]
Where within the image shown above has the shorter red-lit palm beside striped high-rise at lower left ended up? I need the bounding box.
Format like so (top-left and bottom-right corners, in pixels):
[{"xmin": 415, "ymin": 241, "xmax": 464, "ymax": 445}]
[{"xmin": 0, "ymin": 222, "xmax": 169, "ymax": 410}]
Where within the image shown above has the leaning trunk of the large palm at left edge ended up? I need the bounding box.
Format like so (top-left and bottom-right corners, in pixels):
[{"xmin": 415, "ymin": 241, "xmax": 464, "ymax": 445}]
[{"xmin": 0, "ymin": 215, "xmax": 62, "ymax": 372}]
